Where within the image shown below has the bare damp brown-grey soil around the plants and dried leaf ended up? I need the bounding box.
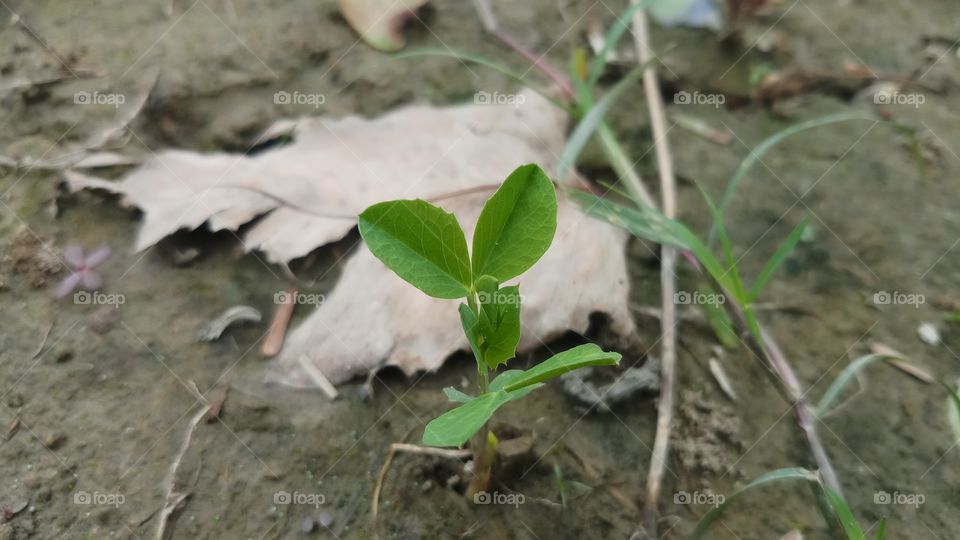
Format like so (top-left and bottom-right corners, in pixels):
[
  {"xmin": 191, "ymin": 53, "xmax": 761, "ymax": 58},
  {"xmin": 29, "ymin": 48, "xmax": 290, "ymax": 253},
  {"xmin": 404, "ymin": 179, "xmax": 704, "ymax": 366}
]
[{"xmin": 0, "ymin": 0, "xmax": 960, "ymax": 540}]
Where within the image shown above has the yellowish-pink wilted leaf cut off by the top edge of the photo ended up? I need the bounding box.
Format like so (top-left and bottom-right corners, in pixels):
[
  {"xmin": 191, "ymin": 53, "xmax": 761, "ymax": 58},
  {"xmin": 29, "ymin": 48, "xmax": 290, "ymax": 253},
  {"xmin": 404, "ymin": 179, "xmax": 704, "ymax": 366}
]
[{"xmin": 337, "ymin": 0, "xmax": 427, "ymax": 52}]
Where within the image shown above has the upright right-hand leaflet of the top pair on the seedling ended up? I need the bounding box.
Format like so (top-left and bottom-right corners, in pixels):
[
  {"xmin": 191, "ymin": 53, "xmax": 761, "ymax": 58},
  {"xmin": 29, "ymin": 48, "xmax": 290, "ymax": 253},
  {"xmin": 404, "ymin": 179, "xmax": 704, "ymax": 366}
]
[{"xmin": 473, "ymin": 164, "xmax": 557, "ymax": 282}]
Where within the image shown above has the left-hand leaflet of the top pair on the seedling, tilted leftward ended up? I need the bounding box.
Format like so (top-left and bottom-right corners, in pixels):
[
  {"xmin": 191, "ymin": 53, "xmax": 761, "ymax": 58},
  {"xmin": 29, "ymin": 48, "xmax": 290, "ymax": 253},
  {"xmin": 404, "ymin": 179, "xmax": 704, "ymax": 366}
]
[{"xmin": 359, "ymin": 199, "xmax": 472, "ymax": 298}]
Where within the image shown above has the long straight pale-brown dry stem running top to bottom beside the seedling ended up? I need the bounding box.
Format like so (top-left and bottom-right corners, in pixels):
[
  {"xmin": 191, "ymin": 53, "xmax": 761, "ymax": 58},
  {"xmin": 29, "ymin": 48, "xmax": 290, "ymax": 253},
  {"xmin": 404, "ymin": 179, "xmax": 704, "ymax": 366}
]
[{"xmin": 630, "ymin": 6, "xmax": 677, "ymax": 538}]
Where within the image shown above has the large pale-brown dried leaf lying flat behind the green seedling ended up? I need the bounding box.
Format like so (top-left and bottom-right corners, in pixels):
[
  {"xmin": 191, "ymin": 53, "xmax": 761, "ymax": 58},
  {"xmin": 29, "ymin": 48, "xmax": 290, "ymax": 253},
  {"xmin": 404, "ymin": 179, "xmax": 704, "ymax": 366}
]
[{"xmin": 66, "ymin": 92, "xmax": 633, "ymax": 387}]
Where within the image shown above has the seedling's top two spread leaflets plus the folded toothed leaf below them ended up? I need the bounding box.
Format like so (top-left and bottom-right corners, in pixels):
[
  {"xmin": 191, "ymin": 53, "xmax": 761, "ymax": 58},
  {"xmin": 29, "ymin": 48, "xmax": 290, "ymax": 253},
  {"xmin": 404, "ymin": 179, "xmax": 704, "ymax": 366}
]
[{"xmin": 358, "ymin": 164, "xmax": 557, "ymax": 369}]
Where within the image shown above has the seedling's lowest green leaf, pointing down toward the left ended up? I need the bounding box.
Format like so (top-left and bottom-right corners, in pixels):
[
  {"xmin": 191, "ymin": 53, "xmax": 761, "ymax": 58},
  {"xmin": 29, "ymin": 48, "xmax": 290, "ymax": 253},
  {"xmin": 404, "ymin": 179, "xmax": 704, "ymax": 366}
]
[{"xmin": 423, "ymin": 370, "xmax": 537, "ymax": 446}]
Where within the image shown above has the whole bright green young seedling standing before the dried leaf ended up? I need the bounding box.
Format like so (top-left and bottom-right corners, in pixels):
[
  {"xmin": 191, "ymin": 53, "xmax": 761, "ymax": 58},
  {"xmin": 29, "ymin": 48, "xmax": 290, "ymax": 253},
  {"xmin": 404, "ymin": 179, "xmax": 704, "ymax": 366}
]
[{"xmin": 359, "ymin": 164, "xmax": 620, "ymax": 496}]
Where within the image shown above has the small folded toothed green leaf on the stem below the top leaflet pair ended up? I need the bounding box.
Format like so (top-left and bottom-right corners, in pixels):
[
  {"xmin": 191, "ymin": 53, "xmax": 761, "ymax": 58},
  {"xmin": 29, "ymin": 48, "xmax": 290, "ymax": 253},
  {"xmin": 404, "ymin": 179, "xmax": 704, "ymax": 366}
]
[{"xmin": 477, "ymin": 285, "xmax": 520, "ymax": 369}]
